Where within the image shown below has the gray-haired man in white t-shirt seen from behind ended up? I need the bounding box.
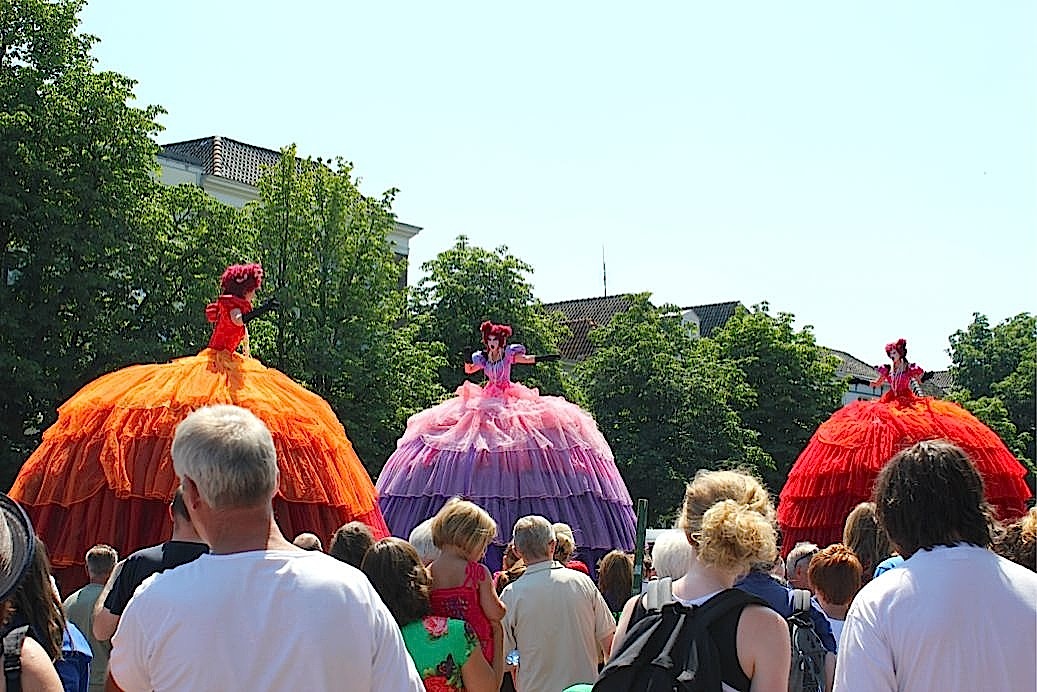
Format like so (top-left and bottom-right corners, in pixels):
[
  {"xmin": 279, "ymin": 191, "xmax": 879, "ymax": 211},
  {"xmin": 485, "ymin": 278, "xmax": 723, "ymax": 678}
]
[{"xmin": 110, "ymin": 406, "xmax": 423, "ymax": 692}]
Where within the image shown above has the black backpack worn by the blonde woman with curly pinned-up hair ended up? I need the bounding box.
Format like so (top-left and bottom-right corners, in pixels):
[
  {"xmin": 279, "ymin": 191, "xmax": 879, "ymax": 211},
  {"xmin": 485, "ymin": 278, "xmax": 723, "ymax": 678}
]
[{"xmin": 593, "ymin": 579, "xmax": 764, "ymax": 692}]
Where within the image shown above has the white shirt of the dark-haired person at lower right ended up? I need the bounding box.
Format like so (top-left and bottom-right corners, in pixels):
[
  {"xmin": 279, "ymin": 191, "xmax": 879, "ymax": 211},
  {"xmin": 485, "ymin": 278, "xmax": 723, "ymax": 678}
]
[{"xmin": 835, "ymin": 545, "xmax": 1037, "ymax": 692}]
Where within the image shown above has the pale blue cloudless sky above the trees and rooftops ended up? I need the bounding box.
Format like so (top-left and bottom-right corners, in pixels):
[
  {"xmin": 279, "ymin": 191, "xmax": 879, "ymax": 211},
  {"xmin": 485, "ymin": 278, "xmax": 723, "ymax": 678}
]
[{"xmin": 76, "ymin": 0, "xmax": 1037, "ymax": 369}]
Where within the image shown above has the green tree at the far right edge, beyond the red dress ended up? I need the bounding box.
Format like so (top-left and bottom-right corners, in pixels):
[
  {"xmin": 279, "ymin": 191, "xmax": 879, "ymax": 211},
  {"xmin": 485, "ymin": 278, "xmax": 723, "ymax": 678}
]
[{"xmin": 950, "ymin": 312, "xmax": 1037, "ymax": 477}]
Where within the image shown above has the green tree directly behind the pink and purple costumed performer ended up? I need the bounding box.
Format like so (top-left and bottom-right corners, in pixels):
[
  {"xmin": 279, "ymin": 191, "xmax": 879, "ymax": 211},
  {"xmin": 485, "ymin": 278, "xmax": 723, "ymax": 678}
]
[{"xmin": 413, "ymin": 236, "xmax": 570, "ymax": 394}]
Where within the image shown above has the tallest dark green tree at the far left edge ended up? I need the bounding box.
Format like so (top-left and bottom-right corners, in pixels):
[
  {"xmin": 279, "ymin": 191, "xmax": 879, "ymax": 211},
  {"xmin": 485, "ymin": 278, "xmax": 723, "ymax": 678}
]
[{"xmin": 0, "ymin": 0, "xmax": 160, "ymax": 480}]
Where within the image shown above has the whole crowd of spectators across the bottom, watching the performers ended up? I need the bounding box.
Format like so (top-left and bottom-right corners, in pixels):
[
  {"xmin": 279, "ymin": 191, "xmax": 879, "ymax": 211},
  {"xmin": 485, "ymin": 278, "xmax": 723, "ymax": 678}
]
[{"xmin": 0, "ymin": 406, "xmax": 1037, "ymax": 692}]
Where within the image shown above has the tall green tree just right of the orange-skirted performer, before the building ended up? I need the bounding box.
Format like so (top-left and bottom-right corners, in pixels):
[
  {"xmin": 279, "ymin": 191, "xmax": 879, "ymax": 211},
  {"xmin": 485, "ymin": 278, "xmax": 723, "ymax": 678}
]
[{"xmin": 250, "ymin": 146, "xmax": 443, "ymax": 474}]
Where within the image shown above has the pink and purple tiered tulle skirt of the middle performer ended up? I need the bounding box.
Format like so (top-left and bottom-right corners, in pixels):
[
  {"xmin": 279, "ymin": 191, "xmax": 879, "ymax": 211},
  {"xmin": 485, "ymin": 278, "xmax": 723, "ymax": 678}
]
[{"xmin": 377, "ymin": 382, "xmax": 636, "ymax": 550}]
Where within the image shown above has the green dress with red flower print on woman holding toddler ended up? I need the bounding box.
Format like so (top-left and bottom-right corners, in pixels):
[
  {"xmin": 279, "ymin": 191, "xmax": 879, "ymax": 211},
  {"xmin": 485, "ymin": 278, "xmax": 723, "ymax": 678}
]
[{"xmin": 400, "ymin": 615, "xmax": 479, "ymax": 692}]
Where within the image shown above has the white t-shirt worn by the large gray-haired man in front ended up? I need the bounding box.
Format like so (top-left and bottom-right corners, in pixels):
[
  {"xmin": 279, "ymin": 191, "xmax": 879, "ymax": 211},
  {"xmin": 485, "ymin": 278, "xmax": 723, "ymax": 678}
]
[{"xmin": 110, "ymin": 550, "xmax": 424, "ymax": 692}]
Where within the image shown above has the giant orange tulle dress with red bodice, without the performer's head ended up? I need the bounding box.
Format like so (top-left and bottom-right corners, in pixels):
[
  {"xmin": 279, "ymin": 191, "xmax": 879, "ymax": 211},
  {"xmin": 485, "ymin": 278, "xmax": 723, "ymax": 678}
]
[{"xmin": 10, "ymin": 296, "xmax": 389, "ymax": 591}]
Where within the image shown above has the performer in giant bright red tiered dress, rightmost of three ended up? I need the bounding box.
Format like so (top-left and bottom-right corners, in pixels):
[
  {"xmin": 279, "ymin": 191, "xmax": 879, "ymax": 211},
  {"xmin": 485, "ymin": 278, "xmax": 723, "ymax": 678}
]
[{"xmin": 778, "ymin": 339, "xmax": 1030, "ymax": 551}]
